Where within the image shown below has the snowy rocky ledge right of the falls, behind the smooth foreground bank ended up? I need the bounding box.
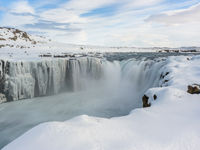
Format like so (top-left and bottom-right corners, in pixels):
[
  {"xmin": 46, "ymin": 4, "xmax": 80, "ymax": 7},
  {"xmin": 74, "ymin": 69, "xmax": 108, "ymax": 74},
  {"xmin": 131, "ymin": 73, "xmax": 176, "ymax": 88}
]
[{"xmin": 141, "ymin": 56, "xmax": 200, "ymax": 108}]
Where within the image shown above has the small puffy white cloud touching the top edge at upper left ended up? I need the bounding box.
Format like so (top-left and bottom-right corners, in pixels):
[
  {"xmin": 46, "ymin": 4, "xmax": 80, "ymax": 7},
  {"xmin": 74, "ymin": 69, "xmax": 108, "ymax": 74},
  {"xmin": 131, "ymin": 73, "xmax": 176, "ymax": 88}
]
[{"xmin": 10, "ymin": 0, "xmax": 35, "ymax": 14}]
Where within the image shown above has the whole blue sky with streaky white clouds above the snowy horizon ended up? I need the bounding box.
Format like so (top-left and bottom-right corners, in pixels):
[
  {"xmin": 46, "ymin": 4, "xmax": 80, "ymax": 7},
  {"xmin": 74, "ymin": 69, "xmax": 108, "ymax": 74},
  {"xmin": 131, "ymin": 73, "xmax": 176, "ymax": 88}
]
[{"xmin": 0, "ymin": 0, "xmax": 200, "ymax": 47}]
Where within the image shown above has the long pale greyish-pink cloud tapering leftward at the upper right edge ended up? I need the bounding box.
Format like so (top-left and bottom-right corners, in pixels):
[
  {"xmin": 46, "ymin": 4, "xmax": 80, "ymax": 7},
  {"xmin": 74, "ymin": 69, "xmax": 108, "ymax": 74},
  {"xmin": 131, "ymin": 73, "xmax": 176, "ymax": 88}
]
[{"xmin": 146, "ymin": 3, "xmax": 200, "ymax": 25}]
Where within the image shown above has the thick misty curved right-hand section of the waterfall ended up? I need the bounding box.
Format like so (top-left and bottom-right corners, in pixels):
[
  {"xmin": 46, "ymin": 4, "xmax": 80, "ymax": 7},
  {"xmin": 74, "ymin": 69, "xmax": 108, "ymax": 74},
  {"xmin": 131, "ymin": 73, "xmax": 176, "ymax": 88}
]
[{"xmin": 101, "ymin": 59, "xmax": 165, "ymax": 108}]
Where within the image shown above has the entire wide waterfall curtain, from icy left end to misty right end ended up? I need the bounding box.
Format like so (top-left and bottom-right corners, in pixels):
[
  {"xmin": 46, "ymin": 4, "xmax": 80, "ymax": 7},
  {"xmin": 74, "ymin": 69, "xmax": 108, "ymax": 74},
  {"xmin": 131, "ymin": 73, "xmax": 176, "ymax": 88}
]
[{"xmin": 0, "ymin": 57, "xmax": 166, "ymax": 101}]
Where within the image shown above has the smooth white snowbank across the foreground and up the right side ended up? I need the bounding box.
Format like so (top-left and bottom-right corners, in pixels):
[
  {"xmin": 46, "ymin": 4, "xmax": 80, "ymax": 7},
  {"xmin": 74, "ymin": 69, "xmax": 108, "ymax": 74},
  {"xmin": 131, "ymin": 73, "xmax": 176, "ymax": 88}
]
[{"xmin": 3, "ymin": 56, "xmax": 200, "ymax": 150}]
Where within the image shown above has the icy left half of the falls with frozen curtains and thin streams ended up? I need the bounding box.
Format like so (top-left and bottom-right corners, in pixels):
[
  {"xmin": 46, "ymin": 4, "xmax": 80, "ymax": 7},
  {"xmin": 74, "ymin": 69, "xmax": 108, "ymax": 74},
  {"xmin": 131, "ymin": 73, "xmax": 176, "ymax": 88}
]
[{"xmin": 0, "ymin": 57, "xmax": 101, "ymax": 101}]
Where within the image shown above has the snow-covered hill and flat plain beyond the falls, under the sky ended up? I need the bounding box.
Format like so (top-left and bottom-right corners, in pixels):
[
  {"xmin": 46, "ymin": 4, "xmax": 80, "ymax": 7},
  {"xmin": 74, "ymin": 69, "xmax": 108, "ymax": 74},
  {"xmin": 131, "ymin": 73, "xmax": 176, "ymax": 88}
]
[{"xmin": 0, "ymin": 27, "xmax": 200, "ymax": 60}]
